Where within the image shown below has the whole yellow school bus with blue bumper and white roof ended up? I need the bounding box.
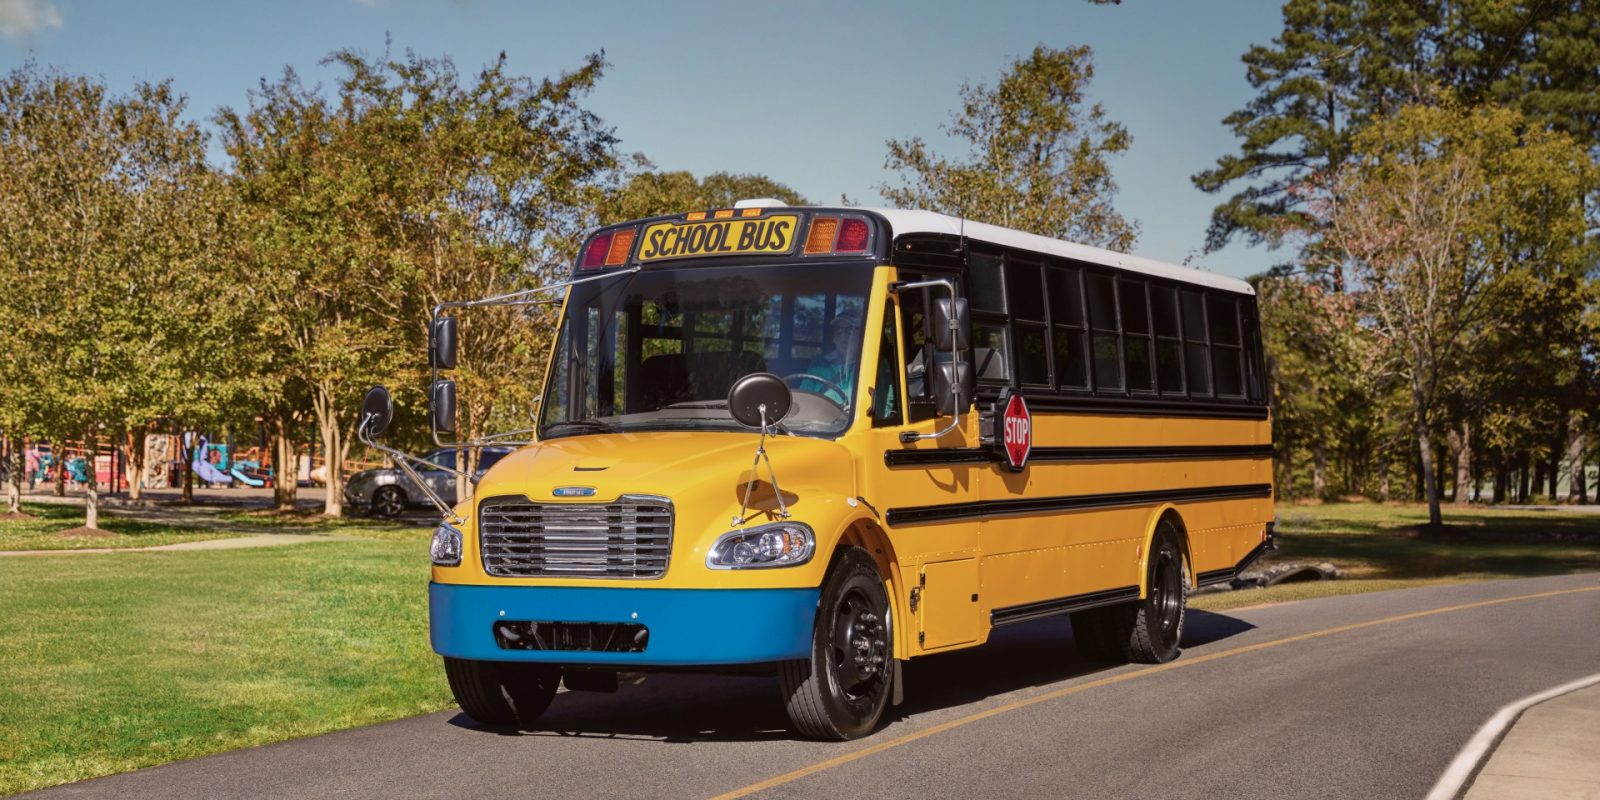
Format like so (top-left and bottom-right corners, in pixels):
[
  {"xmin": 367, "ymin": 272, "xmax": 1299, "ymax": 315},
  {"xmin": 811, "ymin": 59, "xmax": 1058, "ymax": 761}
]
[{"xmin": 380, "ymin": 202, "xmax": 1274, "ymax": 739}]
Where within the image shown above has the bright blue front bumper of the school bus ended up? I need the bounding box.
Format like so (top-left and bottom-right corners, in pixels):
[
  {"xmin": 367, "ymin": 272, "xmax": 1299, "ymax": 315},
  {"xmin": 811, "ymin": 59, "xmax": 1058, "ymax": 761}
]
[{"xmin": 427, "ymin": 582, "xmax": 819, "ymax": 666}]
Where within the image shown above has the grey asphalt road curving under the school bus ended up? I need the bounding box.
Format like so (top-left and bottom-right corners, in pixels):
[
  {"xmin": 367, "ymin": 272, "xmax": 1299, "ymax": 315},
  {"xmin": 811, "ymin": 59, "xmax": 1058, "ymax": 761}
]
[{"xmin": 25, "ymin": 574, "xmax": 1600, "ymax": 800}]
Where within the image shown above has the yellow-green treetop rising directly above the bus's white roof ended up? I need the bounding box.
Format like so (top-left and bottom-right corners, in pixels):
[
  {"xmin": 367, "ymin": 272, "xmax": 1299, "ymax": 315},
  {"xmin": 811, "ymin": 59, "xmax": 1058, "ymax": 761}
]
[{"xmin": 878, "ymin": 45, "xmax": 1138, "ymax": 250}]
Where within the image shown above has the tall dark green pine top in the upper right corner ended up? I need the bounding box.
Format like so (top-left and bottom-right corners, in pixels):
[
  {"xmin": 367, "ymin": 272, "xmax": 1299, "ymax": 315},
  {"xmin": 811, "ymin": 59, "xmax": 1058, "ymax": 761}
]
[{"xmin": 1194, "ymin": 0, "xmax": 1600, "ymax": 262}]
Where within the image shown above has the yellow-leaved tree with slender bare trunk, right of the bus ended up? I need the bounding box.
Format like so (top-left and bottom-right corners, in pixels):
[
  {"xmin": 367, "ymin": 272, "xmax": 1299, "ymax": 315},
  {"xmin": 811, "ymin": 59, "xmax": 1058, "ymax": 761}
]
[{"xmin": 1307, "ymin": 102, "xmax": 1595, "ymax": 525}]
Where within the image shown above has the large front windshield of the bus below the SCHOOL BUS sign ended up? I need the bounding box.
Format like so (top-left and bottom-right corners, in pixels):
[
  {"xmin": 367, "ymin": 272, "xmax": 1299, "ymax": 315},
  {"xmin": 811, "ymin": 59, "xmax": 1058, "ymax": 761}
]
[{"xmin": 539, "ymin": 264, "xmax": 872, "ymax": 438}]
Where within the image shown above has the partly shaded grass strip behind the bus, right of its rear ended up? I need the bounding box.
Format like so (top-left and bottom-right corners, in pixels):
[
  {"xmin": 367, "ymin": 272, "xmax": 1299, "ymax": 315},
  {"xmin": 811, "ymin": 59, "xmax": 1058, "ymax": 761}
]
[{"xmin": 1194, "ymin": 502, "xmax": 1600, "ymax": 611}]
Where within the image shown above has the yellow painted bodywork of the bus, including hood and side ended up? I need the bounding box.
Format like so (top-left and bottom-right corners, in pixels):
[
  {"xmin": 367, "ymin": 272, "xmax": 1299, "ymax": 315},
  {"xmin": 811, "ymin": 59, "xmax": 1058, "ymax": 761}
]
[{"xmin": 434, "ymin": 267, "xmax": 1272, "ymax": 658}]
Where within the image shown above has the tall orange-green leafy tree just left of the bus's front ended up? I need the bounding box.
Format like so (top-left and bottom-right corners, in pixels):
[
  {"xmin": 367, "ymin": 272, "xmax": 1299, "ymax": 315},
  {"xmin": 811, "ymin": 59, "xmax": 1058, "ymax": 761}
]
[{"xmin": 219, "ymin": 51, "xmax": 616, "ymax": 515}]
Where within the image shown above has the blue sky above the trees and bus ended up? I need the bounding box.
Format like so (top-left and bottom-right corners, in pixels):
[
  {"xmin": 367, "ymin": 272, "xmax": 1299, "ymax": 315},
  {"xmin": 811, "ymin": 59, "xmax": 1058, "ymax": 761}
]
[{"xmin": 0, "ymin": 0, "xmax": 1282, "ymax": 277}]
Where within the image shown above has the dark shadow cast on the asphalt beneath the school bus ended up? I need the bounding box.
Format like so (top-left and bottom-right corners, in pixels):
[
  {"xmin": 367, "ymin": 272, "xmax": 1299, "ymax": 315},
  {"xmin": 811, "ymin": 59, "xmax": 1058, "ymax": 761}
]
[{"xmin": 450, "ymin": 608, "xmax": 1254, "ymax": 744}]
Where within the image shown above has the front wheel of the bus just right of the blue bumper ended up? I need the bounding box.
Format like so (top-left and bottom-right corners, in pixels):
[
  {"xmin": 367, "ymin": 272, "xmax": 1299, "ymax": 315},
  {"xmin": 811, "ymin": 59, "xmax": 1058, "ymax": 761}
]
[{"xmin": 778, "ymin": 547, "xmax": 894, "ymax": 741}]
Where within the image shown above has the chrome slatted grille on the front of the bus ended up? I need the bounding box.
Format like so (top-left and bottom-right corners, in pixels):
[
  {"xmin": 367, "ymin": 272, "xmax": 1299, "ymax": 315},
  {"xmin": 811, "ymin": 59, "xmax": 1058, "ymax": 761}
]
[{"xmin": 478, "ymin": 494, "xmax": 672, "ymax": 578}]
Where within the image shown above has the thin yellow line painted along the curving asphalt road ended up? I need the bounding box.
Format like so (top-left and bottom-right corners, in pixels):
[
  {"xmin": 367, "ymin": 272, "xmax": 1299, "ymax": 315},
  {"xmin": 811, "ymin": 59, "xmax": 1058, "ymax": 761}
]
[{"xmin": 712, "ymin": 586, "xmax": 1600, "ymax": 800}]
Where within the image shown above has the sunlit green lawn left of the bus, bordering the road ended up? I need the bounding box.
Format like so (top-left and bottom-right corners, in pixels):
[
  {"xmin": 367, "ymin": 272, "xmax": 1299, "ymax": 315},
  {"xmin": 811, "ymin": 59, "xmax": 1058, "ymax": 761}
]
[{"xmin": 0, "ymin": 530, "xmax": 450, "ymax": 795}]
